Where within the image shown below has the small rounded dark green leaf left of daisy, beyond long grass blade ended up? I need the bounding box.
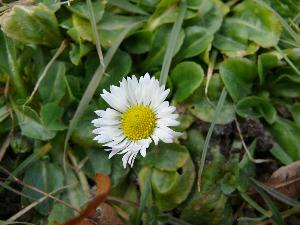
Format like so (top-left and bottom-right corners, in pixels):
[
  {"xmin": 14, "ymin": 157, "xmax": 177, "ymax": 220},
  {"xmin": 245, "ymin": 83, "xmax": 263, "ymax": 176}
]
[{"xmin": 40, "ymin": 102, "xmax": 67, "ymax": 131}]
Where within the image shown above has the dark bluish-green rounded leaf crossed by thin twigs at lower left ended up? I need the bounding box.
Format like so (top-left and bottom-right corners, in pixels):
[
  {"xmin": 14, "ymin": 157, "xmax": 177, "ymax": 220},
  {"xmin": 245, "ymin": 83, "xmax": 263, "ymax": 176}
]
[{"xmin": 23, "ymin": 160, "xmax": 64, "ymax": 215}]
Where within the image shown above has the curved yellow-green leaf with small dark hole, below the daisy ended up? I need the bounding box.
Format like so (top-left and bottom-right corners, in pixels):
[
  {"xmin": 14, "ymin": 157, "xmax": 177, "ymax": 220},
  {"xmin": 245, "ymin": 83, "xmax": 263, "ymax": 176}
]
[{"xmin": 152, "ymin": 155, "xmax": 195, "ymax": 211}]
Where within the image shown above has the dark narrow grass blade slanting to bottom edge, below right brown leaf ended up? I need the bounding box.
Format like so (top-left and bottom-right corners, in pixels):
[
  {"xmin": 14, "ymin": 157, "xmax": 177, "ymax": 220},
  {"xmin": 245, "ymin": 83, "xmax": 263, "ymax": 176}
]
[{"xmin": 251, "ymin": 178, "xmax": 285, "ymax": 225}]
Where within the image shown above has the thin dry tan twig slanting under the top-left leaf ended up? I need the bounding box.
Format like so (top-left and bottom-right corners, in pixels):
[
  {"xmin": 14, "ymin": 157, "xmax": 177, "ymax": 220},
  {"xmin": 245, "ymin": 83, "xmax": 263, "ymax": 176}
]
[{"xmin": 23, "ymin": 40, "xmax": 68, "ymax": 106}]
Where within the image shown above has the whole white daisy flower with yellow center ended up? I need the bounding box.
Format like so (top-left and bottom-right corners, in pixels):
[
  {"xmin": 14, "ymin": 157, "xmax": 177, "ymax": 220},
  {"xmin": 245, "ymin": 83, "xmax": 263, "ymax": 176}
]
[{"xmin": 92, "ymin": 73, "xmax": 181, "ymax": 168}]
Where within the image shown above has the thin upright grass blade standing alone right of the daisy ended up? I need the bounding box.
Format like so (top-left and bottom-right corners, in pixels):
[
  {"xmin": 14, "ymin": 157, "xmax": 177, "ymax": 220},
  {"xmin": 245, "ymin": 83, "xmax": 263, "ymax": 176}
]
[{"xmin": 197, "ymin": 88, "xmax": 227, "ymax": 192}]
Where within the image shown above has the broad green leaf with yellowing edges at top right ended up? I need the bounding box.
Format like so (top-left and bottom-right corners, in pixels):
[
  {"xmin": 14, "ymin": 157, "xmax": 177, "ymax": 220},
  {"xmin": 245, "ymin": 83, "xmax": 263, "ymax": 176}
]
[{"xmin": 214, "ymin": 0, "xmax": 281, "ymax": 56}]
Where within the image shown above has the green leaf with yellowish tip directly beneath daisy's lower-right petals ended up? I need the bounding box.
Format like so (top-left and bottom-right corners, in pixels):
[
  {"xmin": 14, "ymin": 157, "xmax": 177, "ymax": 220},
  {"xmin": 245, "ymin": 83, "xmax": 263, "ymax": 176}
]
[{"xmin": 139, "ymin": 142, "xmax": 189, "ymax": 171}]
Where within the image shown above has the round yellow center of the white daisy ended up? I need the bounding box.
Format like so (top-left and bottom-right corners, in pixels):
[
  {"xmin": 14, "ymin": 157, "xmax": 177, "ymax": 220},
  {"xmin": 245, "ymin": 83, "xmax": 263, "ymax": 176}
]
[{"xmin": 121, "ymin": 105, "xmax": 156, "ymax": 141}]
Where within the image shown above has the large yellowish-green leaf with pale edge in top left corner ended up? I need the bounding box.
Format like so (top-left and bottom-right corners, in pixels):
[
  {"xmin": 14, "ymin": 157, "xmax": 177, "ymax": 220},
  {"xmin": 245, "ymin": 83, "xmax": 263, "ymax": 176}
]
[{"xmin": 0, "ymin": 3, "xmax": 62, "ymax": 47}]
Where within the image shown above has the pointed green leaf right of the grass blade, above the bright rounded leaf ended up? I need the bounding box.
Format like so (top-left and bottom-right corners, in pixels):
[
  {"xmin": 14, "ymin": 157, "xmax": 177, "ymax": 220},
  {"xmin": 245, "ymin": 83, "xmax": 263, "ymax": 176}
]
[{"xmin": 177, "ymin": 26, "xmax": 213, "ymax": 59}]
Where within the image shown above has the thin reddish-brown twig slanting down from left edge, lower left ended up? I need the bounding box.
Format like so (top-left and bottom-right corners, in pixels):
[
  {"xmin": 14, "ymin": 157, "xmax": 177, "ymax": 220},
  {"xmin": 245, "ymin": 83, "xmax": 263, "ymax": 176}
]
[{"xmin": 0, "ymin": 165, "xmax": 80, "ymax": 213}]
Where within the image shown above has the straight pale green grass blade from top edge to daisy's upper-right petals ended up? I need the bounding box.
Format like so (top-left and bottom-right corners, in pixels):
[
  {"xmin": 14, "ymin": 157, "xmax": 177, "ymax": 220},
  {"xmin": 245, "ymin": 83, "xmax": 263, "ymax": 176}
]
[{"xmin": 159, "ymin": 0, "xmax": 186, "ymax": 85}]
